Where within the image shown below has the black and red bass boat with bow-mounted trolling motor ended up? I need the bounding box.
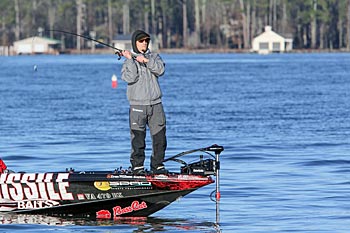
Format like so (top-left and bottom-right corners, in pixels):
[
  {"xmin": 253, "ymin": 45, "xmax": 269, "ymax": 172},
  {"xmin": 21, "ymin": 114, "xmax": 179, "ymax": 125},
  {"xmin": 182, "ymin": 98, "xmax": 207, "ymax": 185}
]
[{"xmin": 0, "ymin": 145, "xmax": 224, "ymax": 219}]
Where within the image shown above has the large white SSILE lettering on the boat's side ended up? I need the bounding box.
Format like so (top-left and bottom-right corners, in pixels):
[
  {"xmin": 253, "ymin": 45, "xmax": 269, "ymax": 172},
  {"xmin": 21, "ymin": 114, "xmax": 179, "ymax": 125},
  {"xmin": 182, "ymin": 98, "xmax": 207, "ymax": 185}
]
[{"xmin": 0, "ymin": 173, "xmax": 74, "ymax": 201}]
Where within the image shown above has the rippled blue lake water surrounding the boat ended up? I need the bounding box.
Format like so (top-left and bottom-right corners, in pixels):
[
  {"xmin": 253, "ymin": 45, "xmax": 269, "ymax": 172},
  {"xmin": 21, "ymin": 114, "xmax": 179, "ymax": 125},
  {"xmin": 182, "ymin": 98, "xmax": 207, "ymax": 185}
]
[{"xmin": 0, "ymin": 53, "xmax": 350, "ymax": 233}]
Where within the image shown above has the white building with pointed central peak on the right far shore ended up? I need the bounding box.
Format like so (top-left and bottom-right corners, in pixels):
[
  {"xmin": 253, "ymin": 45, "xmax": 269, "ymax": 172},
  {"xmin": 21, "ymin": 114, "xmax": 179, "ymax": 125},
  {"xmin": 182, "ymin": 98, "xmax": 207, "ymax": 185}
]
[{"xmin": 252, "ymin": 26, "xmax": 293, "ymax": 54}]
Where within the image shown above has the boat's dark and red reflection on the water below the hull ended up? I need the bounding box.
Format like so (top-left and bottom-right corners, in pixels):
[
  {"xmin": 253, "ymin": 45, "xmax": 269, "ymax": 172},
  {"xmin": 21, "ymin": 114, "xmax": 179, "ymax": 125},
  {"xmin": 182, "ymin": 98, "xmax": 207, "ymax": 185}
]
[{"xmin": 0, "ymin": 213, "xmax": 221, "ymax": 232}]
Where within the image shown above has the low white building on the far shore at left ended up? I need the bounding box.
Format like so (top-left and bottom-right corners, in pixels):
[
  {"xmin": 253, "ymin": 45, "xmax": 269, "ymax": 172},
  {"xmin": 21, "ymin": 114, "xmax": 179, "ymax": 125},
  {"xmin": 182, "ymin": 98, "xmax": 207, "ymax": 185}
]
[{"xmin": 13, "ymin": 36, "xmax": 60, "ymax": 55}]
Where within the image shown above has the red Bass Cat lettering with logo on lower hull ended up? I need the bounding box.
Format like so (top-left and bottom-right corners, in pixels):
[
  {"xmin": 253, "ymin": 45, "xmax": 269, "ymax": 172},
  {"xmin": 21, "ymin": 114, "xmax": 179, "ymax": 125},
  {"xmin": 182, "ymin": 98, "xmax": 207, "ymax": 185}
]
[{"xmin": 96, "ymin": 201, "xmax": 147, "ymax": 219}]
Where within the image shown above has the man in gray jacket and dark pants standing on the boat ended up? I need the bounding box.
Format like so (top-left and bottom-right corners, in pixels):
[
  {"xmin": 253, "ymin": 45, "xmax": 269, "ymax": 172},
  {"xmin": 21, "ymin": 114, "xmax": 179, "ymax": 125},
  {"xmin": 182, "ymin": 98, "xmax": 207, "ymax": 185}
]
[{"xmin": 121, "ymin": 30, "xmax": 167, "ymax": 175}]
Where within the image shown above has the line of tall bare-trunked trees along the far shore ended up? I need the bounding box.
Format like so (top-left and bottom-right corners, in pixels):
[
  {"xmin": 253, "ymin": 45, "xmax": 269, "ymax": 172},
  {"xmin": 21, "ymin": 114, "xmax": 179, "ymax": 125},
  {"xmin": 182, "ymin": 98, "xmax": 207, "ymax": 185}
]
[{"xmin": 0, "ymin": 0, "xmax": 350, "ymax": 51}]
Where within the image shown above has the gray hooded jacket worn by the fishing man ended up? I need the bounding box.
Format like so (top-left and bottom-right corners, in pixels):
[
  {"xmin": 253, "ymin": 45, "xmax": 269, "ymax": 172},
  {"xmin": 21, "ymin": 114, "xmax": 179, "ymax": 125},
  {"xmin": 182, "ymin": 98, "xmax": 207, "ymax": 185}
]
[{"xmin": 121, "ymin": 51, "xmax": 165, "ymax": 105}]
